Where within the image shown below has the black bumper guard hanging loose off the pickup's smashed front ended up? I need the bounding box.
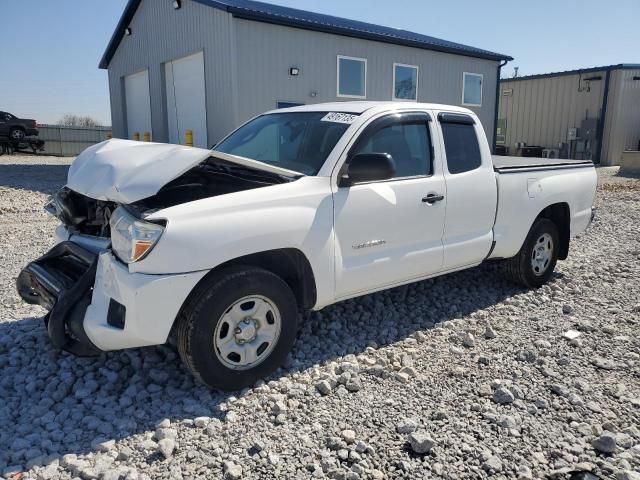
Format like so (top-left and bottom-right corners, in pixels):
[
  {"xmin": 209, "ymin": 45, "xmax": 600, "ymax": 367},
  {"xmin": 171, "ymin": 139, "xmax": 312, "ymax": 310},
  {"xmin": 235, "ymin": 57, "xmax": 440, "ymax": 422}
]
[{"xmin": 16, "ymin": 241, "xmax": 101, "ymax": 356}]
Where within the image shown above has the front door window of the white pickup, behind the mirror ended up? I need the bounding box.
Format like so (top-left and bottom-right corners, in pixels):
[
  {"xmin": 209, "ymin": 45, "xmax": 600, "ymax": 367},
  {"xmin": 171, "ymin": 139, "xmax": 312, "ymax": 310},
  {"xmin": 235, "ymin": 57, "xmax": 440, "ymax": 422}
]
[{"xmin": 351, "ymin": 121, "xmax": 432, "ymax": 178}]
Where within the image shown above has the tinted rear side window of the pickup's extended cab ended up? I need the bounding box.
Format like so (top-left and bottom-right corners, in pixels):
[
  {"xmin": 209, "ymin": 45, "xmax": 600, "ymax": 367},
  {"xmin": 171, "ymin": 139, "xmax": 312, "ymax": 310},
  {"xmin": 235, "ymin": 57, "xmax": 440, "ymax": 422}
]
[{"xmin": 440, "ymin": 123, "xmax": 482, "ymax": 174}]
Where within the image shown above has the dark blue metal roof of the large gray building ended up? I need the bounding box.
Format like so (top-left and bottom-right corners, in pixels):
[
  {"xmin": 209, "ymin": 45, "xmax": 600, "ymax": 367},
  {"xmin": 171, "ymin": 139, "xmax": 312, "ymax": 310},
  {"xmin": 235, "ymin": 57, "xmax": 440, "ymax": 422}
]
[{"xmin": 100, "ymin": 0, "xmax": 513, "ymax": 69}]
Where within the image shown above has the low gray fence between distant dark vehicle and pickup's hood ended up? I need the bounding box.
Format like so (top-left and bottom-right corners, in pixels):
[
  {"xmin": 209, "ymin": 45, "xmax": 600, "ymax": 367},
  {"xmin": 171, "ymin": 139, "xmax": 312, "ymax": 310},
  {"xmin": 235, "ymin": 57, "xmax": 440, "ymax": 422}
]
[{"xmin": 38, "ymin": 125, "xmax": 111, "ymax": 156}]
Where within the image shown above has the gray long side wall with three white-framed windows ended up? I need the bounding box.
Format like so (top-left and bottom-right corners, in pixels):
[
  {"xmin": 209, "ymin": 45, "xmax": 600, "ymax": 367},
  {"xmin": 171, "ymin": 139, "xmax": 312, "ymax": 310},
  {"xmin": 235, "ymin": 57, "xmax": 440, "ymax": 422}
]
[{"xmin": 235, "ymin": 19, "xmax": 498, "ymax": 141}]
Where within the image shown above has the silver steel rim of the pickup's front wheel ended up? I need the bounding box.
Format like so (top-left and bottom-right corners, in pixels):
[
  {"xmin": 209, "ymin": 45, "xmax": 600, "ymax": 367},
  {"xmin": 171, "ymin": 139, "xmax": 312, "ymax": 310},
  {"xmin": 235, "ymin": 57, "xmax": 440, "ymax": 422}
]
[{"xmin": 213, "ymin": 295, "xmax": 282, "ymax": 370}]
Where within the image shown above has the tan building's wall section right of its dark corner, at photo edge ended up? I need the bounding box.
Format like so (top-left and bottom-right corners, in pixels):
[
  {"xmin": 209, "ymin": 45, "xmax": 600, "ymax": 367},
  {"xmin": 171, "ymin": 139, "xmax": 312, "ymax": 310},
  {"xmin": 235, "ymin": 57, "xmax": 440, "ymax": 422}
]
[{"xmin": 602, "ymin": 69, "xmax": 640, "ymax": 165}]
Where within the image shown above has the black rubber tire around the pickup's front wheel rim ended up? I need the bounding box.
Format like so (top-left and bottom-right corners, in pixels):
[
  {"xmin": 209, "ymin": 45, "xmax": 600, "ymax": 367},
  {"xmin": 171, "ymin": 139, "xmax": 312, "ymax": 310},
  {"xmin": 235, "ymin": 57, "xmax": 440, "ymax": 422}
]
[{"xmin": 176, "ymin": 266, "xmax": 298, "ymax": 391}]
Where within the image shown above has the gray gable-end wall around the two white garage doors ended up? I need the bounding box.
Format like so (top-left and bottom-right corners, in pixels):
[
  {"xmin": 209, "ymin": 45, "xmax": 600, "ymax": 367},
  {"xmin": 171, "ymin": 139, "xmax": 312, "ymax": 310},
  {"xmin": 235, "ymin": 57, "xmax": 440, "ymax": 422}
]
[{"xmin": 109, "ymin": 0, "xmax": 237, "ymax": 142}]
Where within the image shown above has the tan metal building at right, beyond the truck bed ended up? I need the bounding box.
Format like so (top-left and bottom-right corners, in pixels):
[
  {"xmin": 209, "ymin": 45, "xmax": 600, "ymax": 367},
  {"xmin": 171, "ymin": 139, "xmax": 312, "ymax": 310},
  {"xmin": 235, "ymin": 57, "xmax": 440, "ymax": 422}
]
[{"xmin": 497, "ymin": 64, "xmax": 640, "ymax": 165}]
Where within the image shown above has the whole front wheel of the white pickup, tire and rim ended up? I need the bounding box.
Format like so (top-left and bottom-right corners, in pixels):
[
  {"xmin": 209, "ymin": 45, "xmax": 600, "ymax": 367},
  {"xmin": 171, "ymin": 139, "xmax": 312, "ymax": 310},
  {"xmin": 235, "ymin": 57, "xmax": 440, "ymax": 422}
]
[{"xmin": 177, "ymin": 267, "xmax": 298, "ymax": 391}]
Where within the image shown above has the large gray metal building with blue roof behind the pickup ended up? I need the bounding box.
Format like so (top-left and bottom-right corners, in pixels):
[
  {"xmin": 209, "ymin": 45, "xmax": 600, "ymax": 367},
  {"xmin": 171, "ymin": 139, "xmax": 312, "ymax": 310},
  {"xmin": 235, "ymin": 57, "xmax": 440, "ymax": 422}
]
[{"xmin": 100, "ymin": 0, "xmax": 511, "ymax": 147}]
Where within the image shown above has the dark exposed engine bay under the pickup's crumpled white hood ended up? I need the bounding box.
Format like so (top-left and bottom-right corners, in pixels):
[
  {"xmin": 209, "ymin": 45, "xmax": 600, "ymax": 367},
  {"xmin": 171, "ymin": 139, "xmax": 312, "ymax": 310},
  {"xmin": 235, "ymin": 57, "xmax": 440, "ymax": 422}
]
[{"xmin": 45, "ymin": 157, "xmax": 295, "ymax": 238}]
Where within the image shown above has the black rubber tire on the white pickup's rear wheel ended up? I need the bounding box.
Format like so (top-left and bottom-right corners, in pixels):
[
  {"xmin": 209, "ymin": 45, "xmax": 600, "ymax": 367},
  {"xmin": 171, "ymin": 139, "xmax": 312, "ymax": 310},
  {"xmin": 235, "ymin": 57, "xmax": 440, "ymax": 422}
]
[{"xmin": 504, "ymin": 218, "xmax": 560, "ymax": 288}]
